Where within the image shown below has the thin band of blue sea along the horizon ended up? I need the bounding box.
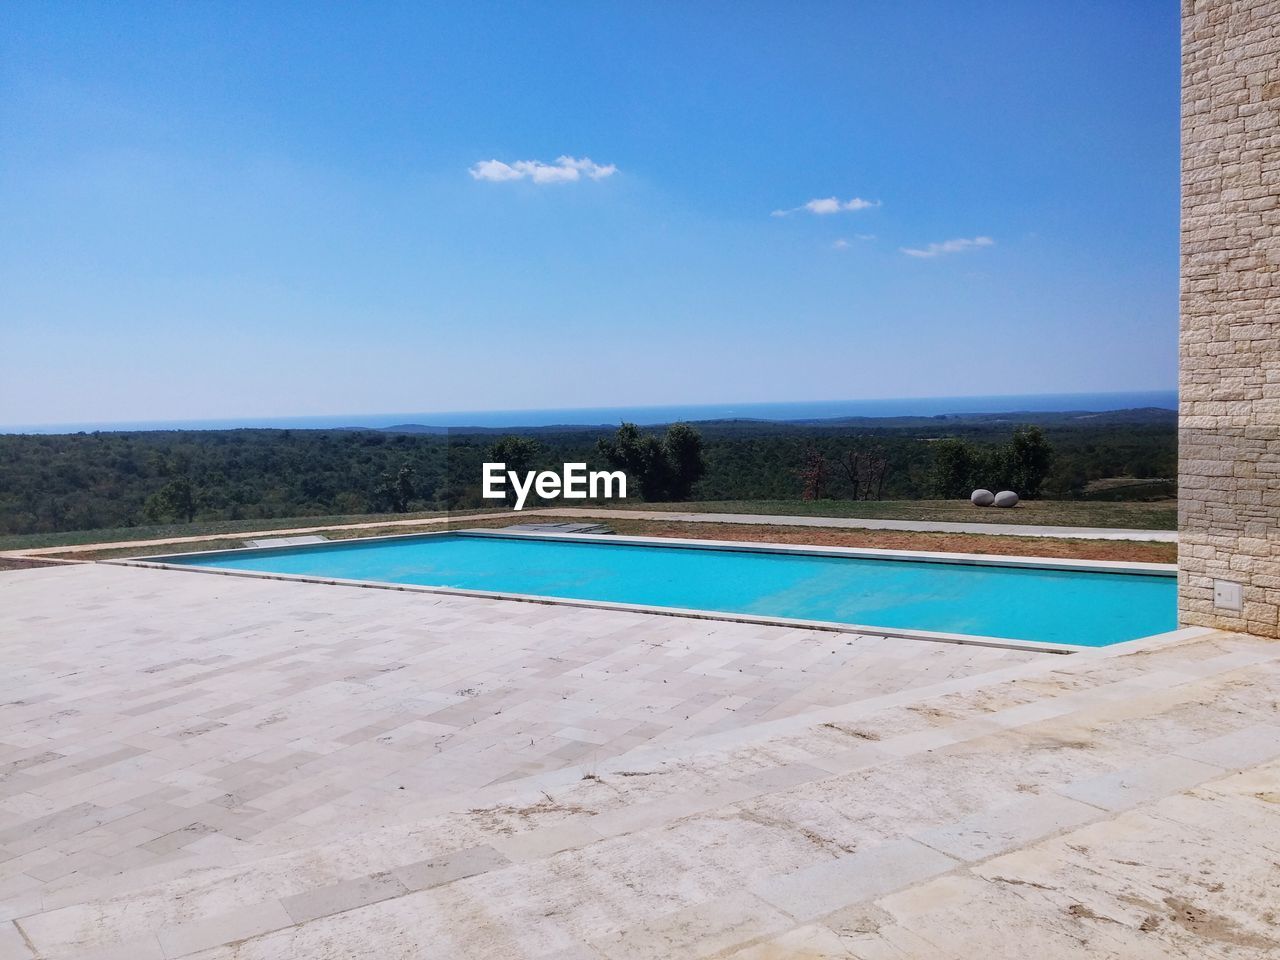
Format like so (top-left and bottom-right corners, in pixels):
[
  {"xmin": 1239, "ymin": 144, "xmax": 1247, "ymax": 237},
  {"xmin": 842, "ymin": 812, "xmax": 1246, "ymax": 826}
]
[{"xmin": 0, "ymin": 390, "xmax": 1178, "ymax": 434}]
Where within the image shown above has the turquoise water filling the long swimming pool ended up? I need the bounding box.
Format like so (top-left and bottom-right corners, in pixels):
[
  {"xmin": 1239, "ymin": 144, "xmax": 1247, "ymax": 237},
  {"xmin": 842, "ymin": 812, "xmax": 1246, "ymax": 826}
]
[{"xmin": 154, "ymin": 534, "xmax": 1175, "ymax": 646}]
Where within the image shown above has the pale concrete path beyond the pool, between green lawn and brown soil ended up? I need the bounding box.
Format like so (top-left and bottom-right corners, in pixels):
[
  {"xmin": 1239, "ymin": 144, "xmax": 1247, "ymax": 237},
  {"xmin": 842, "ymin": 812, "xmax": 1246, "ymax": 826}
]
[{"xmin": 540, "ymin": 507, "xmax": 1178, "ymax": 543}]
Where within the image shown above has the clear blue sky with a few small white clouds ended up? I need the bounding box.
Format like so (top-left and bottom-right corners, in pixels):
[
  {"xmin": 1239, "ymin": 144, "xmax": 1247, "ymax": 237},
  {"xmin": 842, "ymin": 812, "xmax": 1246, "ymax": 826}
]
[{"xmin": 0, "ymin": 0, "xmax": 1179, "ymax": 424}]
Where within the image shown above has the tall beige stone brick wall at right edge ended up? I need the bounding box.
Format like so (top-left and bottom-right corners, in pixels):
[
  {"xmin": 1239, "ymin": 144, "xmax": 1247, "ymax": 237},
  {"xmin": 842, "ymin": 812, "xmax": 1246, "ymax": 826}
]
[{"xmin": 1179, "ymin": 0, "xmax": 1280, "ymax": 636}]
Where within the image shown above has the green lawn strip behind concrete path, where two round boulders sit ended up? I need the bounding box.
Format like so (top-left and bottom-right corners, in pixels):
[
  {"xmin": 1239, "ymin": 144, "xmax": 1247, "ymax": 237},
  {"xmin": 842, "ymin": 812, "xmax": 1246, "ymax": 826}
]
[{"xmin": 609, "ymin": 500, "xmax": 1178, "ymax": 530}]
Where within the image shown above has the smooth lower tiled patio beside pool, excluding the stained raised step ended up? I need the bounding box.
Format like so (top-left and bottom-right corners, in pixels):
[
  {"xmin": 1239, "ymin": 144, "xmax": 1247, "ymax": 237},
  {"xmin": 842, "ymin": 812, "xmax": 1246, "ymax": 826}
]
[{"xmin": 0, "ymin": 564, "xmax": 1037, "ymax": 911}]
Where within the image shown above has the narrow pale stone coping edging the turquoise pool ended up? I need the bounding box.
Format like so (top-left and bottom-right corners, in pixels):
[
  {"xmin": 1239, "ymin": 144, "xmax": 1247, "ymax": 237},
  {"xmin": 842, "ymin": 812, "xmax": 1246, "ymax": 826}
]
[{"xmin": 96, "ymin": 529, "xmax": 1178, "ymax": 654}]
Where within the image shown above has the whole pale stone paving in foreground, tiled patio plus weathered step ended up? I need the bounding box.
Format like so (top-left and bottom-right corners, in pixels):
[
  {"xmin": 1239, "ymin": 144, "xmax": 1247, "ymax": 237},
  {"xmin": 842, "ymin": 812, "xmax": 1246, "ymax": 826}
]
[{"xmin": 0, "ymin": 566, "xmax": 1280, "ymax": 960}]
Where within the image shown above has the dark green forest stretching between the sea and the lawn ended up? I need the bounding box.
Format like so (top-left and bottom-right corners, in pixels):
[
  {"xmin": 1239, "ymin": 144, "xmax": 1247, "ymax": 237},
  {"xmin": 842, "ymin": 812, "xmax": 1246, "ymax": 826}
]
[{"xmin": 0, "ymin": 410, "xmax": 1176, "ymax": 534}]
